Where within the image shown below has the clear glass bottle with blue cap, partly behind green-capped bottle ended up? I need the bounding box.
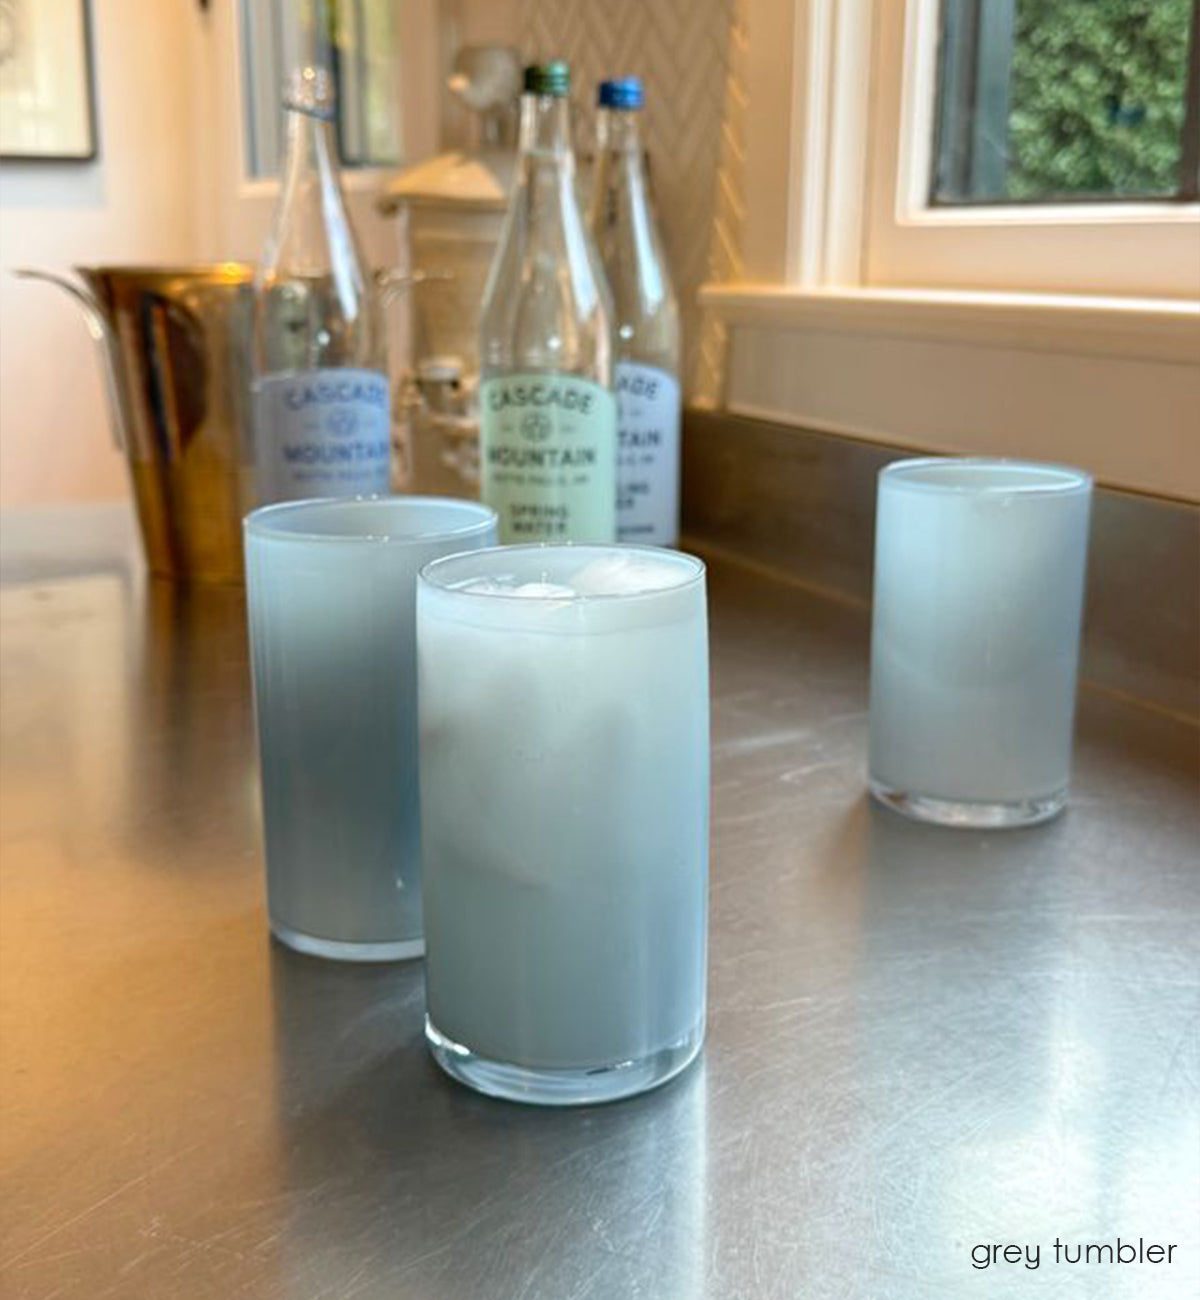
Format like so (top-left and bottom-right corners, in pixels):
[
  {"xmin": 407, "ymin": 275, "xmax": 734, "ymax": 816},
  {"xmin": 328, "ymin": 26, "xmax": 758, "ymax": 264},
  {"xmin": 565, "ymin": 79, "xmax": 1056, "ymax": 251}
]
[{"xmin": 589, "ymin": 77, "xmax": 680, "ymax": 546}]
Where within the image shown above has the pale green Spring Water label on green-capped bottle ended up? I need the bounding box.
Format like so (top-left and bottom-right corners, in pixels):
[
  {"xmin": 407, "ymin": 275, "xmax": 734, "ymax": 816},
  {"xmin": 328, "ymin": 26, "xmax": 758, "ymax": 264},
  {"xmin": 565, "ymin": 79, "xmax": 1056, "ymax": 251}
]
[{"xmin": 480, "ymin": 374, "xmax": 616, "ymax": 543}]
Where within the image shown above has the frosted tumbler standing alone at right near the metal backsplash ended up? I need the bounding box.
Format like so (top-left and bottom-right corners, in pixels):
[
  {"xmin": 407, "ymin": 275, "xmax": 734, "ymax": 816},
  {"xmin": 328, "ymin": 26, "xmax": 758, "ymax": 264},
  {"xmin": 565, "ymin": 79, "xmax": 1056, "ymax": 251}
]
[{"xmin": 870, "ymin": 459, "xmax": 1092, "ymax": 827}]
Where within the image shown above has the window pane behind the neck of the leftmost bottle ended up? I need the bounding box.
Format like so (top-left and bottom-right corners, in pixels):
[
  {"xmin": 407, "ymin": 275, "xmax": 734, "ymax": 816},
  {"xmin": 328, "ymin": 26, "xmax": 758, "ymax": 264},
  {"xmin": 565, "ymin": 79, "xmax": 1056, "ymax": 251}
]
[{"xmin": 242, "ymin": 0, "xmax": 400, "ymax": 177}]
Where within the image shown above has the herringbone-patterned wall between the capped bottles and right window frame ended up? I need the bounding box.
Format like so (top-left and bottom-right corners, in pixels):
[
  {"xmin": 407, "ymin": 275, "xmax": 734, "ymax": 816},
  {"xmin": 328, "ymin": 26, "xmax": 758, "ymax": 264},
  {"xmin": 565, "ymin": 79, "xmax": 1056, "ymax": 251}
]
[{"xmin": 519, "ymin": 0, "xmax": 746, "ymax": 406}]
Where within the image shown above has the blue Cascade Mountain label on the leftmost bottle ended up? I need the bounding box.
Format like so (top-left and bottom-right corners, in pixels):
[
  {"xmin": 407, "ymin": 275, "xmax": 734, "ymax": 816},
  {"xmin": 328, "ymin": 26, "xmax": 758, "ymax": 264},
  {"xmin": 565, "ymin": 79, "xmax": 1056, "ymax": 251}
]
[{"xmin": 255, "ymin": 368, "xmax": 391, "ymax": 503}]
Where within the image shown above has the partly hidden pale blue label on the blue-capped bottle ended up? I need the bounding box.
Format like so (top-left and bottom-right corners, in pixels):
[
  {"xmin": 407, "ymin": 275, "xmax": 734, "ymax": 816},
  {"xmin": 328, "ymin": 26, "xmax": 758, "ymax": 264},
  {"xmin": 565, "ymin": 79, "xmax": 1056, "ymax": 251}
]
[{"xmin": 616, "ymin": 361, "xmax": 680, "ymax": 546}]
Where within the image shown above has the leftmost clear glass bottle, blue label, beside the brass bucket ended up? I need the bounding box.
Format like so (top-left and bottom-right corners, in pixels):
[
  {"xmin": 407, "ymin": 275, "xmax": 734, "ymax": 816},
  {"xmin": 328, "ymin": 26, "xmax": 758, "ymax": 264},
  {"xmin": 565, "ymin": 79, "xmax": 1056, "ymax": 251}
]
[{"xmin": 254, "ymin": 66, "xmax": 391, "ymax": 503}]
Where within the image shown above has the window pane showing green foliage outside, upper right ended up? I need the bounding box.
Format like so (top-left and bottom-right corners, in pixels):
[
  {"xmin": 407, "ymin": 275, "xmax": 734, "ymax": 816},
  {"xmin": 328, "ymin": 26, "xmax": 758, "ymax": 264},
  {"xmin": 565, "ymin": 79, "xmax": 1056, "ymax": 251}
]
[{"xmin": 931, "ymin": 0, "xmax": 1200, "ymax": 204}]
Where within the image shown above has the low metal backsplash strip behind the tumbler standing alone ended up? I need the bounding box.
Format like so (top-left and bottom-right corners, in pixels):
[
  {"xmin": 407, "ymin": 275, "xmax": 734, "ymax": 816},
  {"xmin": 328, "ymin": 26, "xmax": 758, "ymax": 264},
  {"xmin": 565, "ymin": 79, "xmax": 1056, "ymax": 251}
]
[{"xmin": 683, "ymin": 411, "xmax": 1200, "ymax": 719}]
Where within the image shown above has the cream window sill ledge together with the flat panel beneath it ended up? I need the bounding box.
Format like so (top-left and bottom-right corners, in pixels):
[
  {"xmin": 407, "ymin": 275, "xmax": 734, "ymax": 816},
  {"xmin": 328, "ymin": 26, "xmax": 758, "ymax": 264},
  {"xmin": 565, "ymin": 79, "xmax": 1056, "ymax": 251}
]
[{"xmin": 701, "ymin": 283, "xmax": 1200, "ymax": 501}]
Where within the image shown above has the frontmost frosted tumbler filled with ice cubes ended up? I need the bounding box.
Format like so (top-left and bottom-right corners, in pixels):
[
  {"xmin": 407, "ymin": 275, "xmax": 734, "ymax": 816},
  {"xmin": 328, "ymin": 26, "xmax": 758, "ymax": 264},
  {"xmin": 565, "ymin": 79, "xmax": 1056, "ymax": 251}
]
[{"xmin": 417, "ymin": 546, "xmax": 709, "ymax": 1105}]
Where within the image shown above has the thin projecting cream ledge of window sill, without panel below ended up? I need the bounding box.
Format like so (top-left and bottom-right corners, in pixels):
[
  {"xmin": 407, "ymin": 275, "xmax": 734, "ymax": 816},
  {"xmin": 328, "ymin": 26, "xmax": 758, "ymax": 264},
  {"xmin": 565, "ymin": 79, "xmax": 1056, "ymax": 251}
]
[{"xmin": 699, "ymin": 282, "xmax": 1200, "ymax": 365}]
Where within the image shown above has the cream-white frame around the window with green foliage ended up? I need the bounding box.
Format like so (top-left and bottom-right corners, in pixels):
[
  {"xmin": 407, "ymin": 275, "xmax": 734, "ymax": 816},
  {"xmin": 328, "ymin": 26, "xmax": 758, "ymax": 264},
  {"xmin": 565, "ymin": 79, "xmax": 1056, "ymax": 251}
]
[{"xmin": 745, "ymin": 0, "xmax": 1200, "ymax": 300}]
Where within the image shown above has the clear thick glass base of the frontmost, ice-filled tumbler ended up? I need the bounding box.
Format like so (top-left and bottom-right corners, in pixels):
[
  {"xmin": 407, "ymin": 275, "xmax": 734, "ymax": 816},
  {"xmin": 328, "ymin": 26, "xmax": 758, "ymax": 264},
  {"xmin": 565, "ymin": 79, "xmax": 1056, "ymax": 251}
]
[{"xmin": 425, "ymin": 1015, "xmax": 705, "ymax": 1106}]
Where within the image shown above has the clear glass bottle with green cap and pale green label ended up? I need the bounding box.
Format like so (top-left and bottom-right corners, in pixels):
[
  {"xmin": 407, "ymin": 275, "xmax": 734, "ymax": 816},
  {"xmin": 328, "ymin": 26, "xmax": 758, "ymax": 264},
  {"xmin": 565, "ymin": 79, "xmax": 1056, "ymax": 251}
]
[{"xmin": 480, "ymin": 62, "xmax": 616, "ymax": 542}]
